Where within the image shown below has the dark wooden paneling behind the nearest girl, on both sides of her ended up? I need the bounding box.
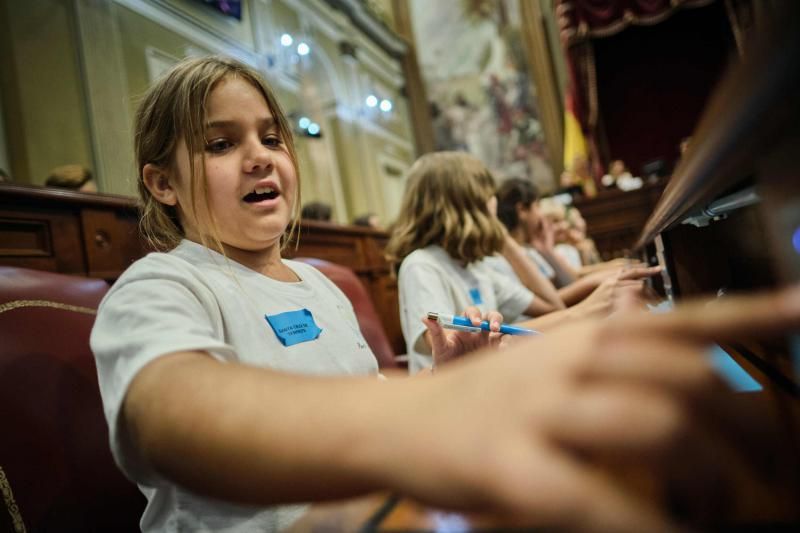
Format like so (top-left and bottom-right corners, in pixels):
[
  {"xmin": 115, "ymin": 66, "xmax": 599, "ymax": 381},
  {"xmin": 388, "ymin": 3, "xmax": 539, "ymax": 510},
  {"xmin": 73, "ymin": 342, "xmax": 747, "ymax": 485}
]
[{"xmin": 0, "ymin": 184, "xmax": 405, "ymax": 354}]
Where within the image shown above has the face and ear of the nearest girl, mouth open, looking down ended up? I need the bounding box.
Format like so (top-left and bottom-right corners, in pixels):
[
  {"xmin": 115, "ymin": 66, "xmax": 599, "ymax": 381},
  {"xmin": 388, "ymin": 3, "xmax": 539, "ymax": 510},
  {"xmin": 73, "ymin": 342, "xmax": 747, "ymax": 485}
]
[{"xmin": 176, "ymin": 77, "xmax": 297, "ymax": 253}]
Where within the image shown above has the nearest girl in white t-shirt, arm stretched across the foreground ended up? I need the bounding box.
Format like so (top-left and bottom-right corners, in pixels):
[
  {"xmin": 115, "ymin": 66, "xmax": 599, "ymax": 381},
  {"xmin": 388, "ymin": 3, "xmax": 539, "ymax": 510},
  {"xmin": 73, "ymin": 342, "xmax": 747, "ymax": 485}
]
[{"xmin": 91, "ymin": 58, "xmax": 800, "ymax": 532}]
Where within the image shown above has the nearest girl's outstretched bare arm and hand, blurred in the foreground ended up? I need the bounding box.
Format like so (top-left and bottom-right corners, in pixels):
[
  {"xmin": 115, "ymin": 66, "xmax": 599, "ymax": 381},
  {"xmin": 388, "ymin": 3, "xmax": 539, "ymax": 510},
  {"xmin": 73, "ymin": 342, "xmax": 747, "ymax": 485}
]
[{"xmin": 120, "ymin": 289, "xmax": 800, "ymax": 531}]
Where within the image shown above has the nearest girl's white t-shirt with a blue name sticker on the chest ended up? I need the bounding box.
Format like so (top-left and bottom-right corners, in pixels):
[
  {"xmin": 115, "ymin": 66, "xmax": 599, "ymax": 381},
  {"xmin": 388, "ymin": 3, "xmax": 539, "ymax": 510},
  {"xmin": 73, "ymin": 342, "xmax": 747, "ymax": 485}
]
[{"xmin": 91, "ymin": 240, "xmax": 378, "ymax": 532}]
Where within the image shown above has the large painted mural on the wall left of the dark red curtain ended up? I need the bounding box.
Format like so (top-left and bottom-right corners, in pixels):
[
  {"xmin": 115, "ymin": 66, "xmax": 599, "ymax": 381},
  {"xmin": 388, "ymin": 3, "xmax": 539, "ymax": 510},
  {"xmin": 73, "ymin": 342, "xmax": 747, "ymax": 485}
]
[{"xmin": 411, "ymin": 0, "xmax": 555, "ymax": 191}]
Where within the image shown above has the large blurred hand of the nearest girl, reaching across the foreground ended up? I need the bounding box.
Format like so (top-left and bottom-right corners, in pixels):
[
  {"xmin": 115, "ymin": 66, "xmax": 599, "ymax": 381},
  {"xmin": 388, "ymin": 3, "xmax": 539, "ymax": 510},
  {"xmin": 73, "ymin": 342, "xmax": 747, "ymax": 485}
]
[{"xmin": 379, "ymin": 282, "xmax": 800, "ymax": 531}]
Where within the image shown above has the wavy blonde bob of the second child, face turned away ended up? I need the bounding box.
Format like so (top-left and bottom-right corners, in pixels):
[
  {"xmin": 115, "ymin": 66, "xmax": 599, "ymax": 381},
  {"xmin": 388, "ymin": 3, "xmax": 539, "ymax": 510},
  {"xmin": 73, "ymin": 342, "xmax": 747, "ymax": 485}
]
[{"xmin": 386, "ymin": 152, "xmax": 503, "ymax": 267}]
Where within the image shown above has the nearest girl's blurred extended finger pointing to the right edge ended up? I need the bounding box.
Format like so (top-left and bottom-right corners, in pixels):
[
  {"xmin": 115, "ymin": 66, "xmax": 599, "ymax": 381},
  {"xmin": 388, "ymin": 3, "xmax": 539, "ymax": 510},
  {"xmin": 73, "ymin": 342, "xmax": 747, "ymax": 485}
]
[{"xmin": 606, "ymin": 286, "xmax": 800, "ymax": 342}]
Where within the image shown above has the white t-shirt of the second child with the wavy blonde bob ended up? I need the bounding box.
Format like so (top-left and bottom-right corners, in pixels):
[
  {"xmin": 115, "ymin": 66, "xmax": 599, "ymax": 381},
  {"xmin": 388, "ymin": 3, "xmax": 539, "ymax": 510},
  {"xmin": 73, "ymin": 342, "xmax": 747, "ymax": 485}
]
[{"xmin": 398, "ymin": 245, "xmax": 534, "ymax": 374}]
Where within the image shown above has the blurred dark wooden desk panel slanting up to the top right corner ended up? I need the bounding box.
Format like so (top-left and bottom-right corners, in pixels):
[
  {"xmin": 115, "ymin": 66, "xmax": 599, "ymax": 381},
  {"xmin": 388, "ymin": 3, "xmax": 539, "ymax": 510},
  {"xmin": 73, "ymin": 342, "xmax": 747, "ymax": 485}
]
[{"xmin": 637, "ymin": 1, "xmax": 800, "ymax": 247}]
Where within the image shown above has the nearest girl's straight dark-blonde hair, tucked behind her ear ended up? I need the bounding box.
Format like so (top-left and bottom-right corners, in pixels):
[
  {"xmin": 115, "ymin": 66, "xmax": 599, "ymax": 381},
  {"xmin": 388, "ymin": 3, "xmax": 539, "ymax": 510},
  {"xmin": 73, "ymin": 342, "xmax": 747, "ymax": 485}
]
[{"xmin": 134, "ymin": 56, "xmax": 300, "ymax": 253}]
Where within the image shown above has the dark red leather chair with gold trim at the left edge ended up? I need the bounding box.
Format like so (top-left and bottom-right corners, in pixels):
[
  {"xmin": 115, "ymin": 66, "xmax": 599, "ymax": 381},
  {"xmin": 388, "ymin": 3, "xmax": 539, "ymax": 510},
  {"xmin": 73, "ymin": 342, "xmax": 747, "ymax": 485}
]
[{"xmin": 0, "ymin": 267, "xmax": 145, "ymax": 532}]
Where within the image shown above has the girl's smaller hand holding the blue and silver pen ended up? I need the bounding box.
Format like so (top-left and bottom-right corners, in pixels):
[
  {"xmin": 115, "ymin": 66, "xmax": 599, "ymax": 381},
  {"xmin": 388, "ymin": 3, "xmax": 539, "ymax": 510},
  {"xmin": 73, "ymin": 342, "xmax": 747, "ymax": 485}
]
[{"xmin": 422, "ymin": 306, "xmax": 503, "ymax": 366}]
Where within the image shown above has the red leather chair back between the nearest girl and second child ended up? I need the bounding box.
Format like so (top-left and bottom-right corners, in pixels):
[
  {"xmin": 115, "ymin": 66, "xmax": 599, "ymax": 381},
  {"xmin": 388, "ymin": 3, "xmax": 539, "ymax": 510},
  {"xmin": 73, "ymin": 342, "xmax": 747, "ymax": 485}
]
[{"xmin": 294, "ymin": 257, "xmax": 398, "ymax": 368}]
